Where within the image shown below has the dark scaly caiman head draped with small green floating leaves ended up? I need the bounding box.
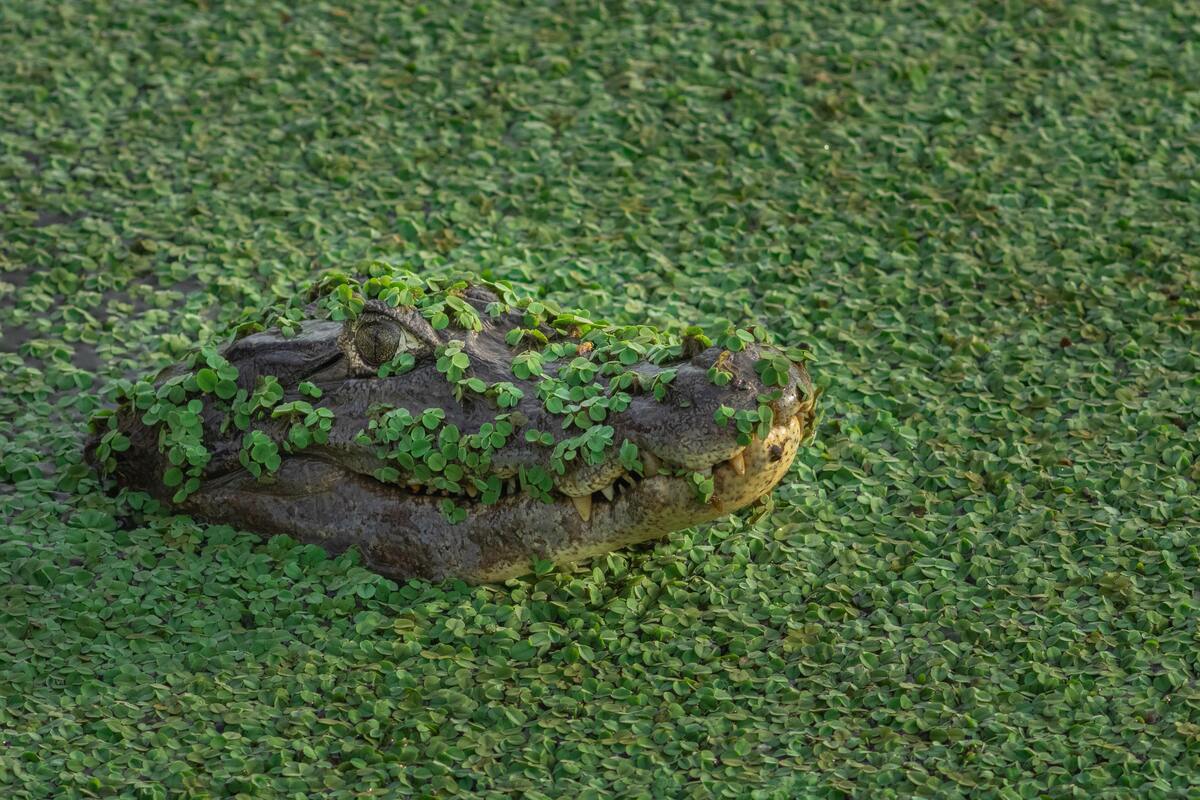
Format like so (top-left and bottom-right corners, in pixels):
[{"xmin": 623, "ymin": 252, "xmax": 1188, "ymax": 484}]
[{"xmin": 88, "ymin": 264, "xmax": 816, "ymax": 582}]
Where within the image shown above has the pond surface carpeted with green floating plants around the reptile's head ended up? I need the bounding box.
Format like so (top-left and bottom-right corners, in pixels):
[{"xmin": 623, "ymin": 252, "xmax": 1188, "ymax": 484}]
[{"xmin": 0, "ymin": 0, "xmax": 1200, "ymax": 800}]
